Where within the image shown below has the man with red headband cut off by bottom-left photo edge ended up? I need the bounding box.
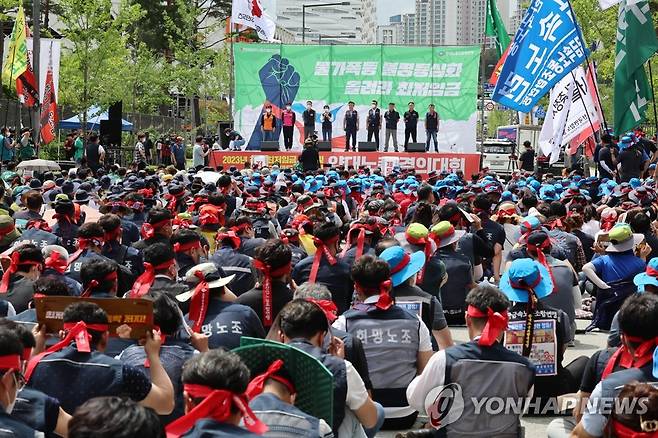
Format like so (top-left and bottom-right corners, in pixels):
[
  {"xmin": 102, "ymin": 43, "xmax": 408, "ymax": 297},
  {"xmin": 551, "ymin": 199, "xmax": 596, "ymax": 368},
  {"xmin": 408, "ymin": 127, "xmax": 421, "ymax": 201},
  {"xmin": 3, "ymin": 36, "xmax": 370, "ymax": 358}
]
[{"xmin": 0, "ymin": 328, "xmax": 36, "ymax": 438}]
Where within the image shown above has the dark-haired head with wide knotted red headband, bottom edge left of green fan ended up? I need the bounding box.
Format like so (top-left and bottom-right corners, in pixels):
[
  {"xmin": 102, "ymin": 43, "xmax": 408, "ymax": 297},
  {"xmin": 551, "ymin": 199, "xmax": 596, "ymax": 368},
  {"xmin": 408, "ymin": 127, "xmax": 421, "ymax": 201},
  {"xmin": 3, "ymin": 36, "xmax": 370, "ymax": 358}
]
[{"xmin": 167, "ymin": 350, "xmax": 267, "ymax": 438}]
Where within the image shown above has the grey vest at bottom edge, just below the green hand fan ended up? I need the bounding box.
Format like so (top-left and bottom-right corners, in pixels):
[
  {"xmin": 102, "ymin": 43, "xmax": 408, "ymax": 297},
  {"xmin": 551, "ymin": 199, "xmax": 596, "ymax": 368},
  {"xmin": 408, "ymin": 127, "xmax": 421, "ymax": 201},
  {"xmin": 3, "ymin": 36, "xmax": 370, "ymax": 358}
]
[{"xmin": 249, "ymin": 394, "xmax": 321, "ymax": 438}]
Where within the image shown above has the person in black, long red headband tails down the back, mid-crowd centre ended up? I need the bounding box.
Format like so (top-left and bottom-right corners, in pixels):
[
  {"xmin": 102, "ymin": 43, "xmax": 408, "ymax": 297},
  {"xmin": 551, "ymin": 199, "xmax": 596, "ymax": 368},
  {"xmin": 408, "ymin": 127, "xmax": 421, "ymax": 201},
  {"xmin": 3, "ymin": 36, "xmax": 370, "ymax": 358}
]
[{"xmin": 292, "ymin": 222, "xmax": 354, "ymax": 314}]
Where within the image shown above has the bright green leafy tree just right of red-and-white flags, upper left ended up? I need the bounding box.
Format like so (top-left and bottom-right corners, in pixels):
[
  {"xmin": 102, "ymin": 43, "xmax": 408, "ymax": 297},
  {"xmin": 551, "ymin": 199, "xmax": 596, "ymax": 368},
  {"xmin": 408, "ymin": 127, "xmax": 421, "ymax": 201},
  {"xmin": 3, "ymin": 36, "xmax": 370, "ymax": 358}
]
[{"xmin": 59, "ymin": 0, "xmax": 143, "ymax": 133}]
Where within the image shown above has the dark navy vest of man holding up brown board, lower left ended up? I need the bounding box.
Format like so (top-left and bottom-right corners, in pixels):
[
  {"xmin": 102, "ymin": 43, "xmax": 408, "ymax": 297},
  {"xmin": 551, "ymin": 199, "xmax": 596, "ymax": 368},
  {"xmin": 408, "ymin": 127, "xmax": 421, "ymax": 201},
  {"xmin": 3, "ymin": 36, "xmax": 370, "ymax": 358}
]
[{"xmin": 28, "ymin": 345, "xmax": 123, "ymax": 412}]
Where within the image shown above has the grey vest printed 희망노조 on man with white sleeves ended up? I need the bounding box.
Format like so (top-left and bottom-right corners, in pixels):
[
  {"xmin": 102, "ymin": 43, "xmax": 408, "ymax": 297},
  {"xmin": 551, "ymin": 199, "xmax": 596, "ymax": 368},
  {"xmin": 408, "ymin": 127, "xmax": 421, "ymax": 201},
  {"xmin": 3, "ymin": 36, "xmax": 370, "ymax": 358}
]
[{"xmin": 343, "ymin": 304, "xmax": 421, "ymax": 407}]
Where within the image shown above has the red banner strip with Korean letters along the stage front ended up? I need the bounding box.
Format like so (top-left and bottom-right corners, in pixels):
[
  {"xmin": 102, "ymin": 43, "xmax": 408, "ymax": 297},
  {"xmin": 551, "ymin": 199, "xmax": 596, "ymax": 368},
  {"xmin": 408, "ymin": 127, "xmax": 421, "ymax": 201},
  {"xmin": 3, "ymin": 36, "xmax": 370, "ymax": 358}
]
[{"xmin": 209, "ymin": 150, "xmax": 480, "ymax": 179}]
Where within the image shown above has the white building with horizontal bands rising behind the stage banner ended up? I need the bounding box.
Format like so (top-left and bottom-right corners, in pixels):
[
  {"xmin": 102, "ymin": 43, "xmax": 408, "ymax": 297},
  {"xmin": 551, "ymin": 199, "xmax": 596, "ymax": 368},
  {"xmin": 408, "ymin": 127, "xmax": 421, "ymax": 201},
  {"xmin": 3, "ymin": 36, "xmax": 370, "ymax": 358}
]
[{"xmin": 277, "ymin": 0, "xmax": 377, "ymax": 44}]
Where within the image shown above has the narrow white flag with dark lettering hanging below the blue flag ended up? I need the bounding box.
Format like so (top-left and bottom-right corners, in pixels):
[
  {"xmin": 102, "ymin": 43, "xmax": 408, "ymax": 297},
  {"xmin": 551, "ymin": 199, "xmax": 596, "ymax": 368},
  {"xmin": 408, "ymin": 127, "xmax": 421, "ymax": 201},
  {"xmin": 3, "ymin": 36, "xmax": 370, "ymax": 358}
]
[{"xmin": 539, "ymin": 75, "xmax": 574, "ymax": 164}]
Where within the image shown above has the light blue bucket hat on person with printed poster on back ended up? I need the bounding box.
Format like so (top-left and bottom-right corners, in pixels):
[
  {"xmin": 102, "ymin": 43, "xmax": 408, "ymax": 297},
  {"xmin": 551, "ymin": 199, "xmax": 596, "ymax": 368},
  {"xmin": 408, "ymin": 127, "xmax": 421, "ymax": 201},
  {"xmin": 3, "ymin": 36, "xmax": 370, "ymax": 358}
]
[{"xmin": 500, "ymin": 259, "xmax": 553, "ymax": 303}]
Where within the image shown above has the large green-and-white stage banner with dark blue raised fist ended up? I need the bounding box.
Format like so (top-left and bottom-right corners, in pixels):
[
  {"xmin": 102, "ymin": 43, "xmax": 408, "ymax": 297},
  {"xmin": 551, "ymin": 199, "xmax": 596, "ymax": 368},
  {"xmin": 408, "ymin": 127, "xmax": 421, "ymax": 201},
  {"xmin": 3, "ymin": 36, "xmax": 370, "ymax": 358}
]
[{"xmin": 233, "ymin": 43, "xmax": 480, "ymax": 153}]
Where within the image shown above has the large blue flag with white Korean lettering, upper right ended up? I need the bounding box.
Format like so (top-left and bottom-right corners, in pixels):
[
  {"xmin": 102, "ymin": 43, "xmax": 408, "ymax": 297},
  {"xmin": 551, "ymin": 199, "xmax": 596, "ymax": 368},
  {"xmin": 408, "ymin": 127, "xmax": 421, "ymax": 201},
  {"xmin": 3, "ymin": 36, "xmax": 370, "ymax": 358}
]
[{"xmin": 492, "ymin": 0, "xmax": 586, "ymax": 113}]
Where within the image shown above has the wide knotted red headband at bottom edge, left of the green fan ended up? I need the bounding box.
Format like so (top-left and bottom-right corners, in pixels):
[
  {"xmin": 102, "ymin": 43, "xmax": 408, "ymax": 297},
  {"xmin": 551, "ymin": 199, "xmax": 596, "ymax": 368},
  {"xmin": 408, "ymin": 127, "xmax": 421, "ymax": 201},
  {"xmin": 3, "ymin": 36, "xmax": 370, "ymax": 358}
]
[{"xmin": 166, "ymin": 384, "xmax": 268, "ymax": 438}]
